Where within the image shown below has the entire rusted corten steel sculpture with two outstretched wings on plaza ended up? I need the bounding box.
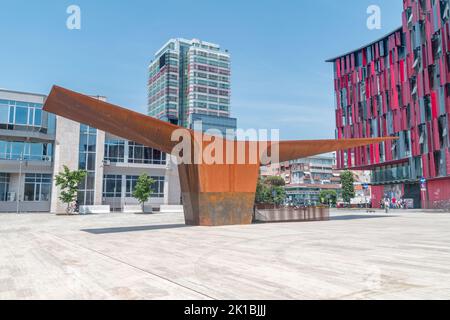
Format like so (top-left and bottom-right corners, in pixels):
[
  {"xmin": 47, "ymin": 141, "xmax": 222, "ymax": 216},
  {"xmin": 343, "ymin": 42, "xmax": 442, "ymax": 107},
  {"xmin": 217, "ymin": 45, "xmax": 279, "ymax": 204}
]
[{"xmin": 44, "ymin": 86, "xmax": 396, "ymax": 226}]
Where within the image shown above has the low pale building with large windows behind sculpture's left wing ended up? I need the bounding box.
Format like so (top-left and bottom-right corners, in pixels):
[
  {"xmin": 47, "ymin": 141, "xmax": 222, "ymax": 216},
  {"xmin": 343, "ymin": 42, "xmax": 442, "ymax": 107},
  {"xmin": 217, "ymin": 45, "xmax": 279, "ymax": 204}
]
[{"xmin": 0, "ymin": 89, "xmax": 181, "ymax": 212}]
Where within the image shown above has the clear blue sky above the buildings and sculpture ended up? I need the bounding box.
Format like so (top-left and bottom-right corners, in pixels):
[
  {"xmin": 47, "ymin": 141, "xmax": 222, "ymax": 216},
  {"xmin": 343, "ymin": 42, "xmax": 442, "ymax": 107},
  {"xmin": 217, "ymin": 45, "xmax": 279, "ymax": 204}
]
[{"xmin": 0, "ymin": 0, "xmax": 402, "ymax": 139}]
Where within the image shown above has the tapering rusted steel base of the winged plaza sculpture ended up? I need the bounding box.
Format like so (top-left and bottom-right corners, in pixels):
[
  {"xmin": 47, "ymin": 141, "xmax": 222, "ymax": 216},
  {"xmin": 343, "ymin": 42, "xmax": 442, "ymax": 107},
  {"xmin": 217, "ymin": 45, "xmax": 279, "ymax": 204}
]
[{"xmin": 178, "ymin": 164, "xmax": 259, "ymax": 226}]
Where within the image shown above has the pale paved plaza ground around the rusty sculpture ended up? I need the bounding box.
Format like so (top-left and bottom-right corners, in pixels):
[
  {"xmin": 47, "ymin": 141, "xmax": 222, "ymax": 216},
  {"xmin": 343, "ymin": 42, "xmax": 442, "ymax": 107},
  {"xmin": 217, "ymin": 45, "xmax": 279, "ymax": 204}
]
[{"xmin": 0, "ymin": 211, "xmax": 450, "ymax": 299}]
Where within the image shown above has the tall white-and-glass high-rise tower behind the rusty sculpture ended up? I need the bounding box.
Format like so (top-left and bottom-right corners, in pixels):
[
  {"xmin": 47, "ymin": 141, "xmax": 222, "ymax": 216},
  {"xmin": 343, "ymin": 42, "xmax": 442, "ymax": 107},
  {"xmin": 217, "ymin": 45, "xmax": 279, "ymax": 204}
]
[{"xmin": 148, "ymin": 39, "xmax": 236, "ymax": 134}]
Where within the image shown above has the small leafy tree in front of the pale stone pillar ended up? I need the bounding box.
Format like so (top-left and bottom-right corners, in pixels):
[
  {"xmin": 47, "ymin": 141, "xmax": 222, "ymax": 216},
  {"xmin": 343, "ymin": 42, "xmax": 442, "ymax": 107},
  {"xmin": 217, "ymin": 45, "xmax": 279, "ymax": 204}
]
[{"xmin": 55, "ymin": 166, "xmax": 87, "ymax": 214}]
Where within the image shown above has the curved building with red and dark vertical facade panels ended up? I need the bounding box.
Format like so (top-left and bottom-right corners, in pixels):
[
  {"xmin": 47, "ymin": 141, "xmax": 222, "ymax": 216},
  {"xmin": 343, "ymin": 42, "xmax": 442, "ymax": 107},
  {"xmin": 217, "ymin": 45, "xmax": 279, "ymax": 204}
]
[{"xmin": 328, "ymin": 0, "xmax": 450, "ymax": 207}]
